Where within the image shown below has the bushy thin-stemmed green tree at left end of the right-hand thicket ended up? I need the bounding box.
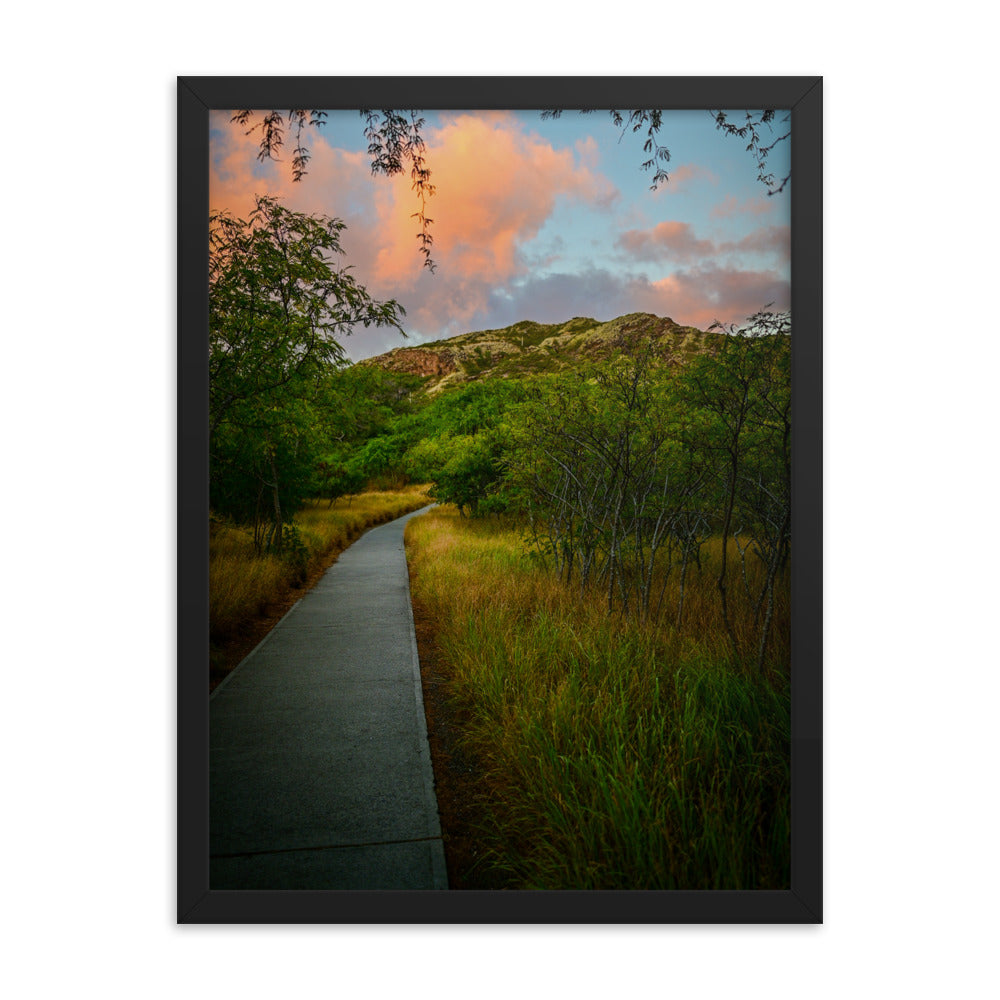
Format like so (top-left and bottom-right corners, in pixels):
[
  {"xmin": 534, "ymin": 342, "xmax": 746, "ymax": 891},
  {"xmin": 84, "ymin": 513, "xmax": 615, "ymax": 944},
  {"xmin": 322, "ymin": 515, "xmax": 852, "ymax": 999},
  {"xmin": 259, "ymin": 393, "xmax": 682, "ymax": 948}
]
[{"xmin": 507, "ymin": 343, "xmax": 682, "ymax": 618}]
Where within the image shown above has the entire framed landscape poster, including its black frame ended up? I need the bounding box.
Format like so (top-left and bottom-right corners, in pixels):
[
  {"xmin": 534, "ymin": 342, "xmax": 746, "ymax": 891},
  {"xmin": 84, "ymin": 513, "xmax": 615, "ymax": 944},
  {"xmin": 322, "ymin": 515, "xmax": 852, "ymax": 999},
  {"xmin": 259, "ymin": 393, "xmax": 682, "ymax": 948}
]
[{"xmin": 178, "ymin": 77, "xmax": 822, "ymax": 923}]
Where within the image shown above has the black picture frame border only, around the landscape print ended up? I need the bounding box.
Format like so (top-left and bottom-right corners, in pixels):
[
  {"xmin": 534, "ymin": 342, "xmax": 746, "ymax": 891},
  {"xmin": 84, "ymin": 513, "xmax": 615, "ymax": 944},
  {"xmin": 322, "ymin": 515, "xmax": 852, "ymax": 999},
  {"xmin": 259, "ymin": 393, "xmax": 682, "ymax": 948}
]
[{"xmin": 177, "ymin": 76, "xmax": 823, "ymax": 924}]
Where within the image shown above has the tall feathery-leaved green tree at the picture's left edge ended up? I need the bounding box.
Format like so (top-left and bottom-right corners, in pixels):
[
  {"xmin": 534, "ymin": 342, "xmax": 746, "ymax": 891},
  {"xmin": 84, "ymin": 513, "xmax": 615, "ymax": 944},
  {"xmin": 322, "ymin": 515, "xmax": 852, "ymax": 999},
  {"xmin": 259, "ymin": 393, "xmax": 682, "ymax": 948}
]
[{"xmin": 209, "ymin": 197, "xmax": 403, "ymax": 548}]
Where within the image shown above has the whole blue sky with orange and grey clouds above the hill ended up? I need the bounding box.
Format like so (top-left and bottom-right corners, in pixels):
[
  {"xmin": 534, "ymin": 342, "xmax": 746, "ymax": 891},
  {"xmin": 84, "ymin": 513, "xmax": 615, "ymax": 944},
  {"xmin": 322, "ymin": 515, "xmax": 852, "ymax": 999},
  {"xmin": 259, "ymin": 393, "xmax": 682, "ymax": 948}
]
[{"xmin": 209, "ymin": 111, "xmax": 791, "ymax": 361}]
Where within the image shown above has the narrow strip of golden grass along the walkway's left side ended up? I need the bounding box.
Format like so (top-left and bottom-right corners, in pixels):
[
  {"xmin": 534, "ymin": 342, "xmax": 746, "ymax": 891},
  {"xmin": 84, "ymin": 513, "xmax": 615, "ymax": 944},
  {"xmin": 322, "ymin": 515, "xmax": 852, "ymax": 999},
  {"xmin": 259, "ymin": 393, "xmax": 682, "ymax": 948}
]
[{"xmin": 209, "ymin": 486, "xmax": 429, "ymax": 682}]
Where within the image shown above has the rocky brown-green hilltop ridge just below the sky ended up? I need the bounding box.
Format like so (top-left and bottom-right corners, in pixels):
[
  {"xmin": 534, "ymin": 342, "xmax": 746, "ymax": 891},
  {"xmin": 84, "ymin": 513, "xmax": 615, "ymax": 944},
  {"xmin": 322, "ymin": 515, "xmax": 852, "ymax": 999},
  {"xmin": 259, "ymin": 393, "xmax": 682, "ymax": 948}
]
[{"xmin": 360, "ymin": 313, "xmax": 720, "ymax": 393}]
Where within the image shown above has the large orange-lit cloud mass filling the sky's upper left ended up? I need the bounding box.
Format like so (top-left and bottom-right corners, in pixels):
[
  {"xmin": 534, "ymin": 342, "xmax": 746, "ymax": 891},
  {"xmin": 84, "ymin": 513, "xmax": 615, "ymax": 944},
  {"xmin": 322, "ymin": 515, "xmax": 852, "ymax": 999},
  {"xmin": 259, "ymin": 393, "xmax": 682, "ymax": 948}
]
[{"xmin": 210, "ymin": 111, "xmax": 618, "ymax": 335}]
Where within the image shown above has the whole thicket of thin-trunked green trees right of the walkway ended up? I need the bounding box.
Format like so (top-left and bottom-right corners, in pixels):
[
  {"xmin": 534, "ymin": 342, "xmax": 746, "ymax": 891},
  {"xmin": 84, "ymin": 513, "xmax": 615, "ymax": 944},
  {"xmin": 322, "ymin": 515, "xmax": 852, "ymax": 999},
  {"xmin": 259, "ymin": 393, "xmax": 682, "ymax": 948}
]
[{"xmin": 505, "ymin": 313, "xmax": 791, "ymax": 667}]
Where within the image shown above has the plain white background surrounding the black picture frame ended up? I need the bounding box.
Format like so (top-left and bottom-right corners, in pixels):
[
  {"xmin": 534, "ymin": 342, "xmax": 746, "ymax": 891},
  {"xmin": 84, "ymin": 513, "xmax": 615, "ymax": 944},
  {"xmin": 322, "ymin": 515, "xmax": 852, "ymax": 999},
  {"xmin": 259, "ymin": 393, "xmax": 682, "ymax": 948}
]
[{"xmin": 0, "ymin": 0, "xmax": 1000, "ymax": 1000}]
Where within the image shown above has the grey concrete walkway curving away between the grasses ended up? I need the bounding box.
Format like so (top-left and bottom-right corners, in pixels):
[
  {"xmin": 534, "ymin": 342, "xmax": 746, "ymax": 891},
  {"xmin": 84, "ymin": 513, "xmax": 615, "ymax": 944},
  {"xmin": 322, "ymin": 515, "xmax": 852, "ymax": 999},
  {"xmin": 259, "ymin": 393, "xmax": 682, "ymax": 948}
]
[{"xmin": 209, "ymin": 507, "xmax": 448, "ymax": 890}]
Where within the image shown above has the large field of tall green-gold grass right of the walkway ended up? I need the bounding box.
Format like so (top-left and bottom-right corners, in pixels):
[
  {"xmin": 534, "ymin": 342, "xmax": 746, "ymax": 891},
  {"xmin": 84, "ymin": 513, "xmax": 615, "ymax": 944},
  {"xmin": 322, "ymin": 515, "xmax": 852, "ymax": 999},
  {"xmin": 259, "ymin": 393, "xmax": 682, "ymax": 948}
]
[{"xmin": 406, "ymin": 507, "xmax": 790, "ymax": 889}]
